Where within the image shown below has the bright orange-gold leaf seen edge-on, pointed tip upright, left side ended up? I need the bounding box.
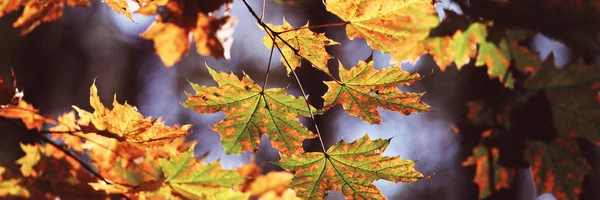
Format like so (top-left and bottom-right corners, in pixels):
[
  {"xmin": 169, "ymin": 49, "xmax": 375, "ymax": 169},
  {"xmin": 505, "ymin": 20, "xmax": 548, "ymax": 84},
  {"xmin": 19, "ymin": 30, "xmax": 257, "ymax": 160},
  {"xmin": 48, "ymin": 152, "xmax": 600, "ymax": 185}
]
[{"xmin": 73, "ymin": 83, "xmax": 191, "ymax": 146}]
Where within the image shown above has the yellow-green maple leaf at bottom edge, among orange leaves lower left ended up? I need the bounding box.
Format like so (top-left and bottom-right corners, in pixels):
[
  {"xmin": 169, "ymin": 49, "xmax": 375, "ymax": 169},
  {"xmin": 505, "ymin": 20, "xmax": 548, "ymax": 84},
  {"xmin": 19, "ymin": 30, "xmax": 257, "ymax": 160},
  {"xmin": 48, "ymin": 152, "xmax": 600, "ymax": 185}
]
[{"xmin": 159, "ymin": 150, "xmax": 250, "ymax": 199}]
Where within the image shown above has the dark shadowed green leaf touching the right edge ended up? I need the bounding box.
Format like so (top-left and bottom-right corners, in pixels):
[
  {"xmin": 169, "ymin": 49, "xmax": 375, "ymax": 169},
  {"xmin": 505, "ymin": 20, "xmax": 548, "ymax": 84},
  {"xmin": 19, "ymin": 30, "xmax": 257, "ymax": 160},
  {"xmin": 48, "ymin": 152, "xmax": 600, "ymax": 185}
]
[{"xmin": 525, "ymin": 57, "xmax": 600, "ymax": 143}]
